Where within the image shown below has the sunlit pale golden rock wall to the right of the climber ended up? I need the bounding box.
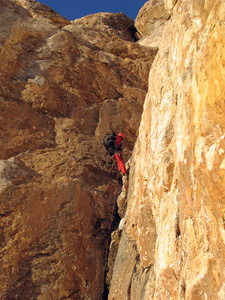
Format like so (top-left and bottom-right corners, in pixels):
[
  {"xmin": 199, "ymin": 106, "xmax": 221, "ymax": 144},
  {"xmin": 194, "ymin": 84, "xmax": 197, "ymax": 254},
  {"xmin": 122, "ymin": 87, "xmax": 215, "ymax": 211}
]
[{"xmin": 109, "ymin": 0, "xmax": 225, "ymax": 300}]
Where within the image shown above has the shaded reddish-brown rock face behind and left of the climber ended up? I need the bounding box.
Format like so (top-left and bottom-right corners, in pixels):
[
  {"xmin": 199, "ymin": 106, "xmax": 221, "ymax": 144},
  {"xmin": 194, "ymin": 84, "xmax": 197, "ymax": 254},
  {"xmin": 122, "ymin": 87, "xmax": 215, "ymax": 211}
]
[{"xmin": 0, "ymin": 0, "xmax": 157, "ymax": 300}]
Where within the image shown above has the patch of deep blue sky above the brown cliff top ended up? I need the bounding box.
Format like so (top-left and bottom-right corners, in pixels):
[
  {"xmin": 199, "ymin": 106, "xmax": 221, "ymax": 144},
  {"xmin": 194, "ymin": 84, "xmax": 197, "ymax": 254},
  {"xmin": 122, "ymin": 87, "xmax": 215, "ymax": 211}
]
[{"xmin": 38, "ymin": 0, "xmax": 147, "ymax": 21}]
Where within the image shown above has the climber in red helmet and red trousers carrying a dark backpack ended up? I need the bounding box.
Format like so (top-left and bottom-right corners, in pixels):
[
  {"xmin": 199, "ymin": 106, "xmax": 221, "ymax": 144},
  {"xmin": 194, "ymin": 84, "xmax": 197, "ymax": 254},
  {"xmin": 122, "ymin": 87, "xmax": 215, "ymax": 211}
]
[{"xmin": 102, "ymin": 132, "xmax": 127, "ymax": 175}]
